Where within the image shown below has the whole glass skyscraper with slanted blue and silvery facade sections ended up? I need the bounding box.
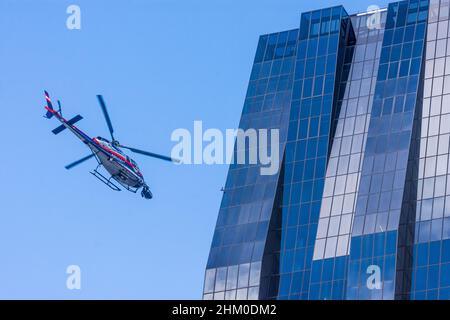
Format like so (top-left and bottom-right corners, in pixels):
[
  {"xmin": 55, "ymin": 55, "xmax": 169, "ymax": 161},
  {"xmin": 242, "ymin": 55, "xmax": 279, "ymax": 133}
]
[{"xmin": 203, "ymin": 0, "xmax": 450, "ymax": 300}]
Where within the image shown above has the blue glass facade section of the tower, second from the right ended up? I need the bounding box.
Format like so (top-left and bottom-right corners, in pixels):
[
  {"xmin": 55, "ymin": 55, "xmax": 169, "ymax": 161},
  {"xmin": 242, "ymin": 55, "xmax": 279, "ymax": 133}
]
[{"xmin": 347, "ymin": 1, "xmax": 428, "ymax": 299}]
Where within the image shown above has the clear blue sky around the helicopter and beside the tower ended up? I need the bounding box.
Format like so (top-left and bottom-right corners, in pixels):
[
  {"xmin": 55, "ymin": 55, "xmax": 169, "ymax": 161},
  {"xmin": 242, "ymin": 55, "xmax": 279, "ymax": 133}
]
[{"xmin": 0, "ymin": 0, "xmax": 387, "ymax": 299}]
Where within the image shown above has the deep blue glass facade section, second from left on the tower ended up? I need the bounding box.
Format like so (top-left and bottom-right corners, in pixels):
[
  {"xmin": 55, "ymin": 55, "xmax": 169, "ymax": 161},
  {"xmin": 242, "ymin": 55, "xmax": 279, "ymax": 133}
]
[{"xmin": 277, "ymin": 7, "xmax": 355, "ymax": 299}]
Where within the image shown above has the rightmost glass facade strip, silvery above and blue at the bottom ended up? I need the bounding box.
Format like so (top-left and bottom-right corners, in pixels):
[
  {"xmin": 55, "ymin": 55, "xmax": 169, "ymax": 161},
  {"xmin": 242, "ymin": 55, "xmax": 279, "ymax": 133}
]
[{"xmin": 410, "ymin": 1, "xmax": 450, "ymax": 300}]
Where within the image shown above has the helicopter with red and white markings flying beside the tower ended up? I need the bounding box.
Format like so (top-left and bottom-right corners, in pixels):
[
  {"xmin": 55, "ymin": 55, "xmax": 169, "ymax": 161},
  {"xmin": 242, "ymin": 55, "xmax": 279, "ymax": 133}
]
[{"xmin": 44, "ymin": 91, "xmax": 180, "ymax": 199}]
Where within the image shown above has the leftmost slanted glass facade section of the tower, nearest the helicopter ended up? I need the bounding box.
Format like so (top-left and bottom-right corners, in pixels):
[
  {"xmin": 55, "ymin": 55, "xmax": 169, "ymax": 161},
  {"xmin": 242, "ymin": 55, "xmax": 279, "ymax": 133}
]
[{"xmin": 204, "ymin": 29, "xmax": 298, "ymax": 299}]
